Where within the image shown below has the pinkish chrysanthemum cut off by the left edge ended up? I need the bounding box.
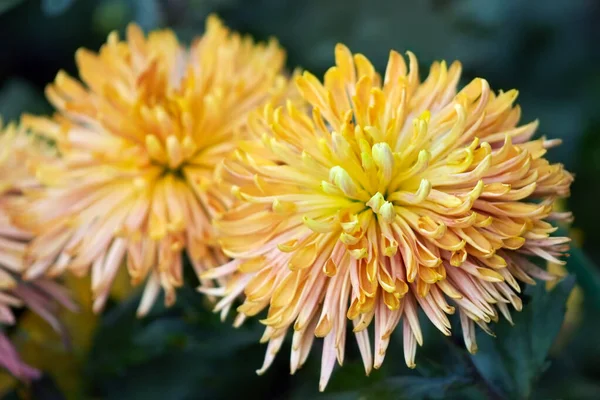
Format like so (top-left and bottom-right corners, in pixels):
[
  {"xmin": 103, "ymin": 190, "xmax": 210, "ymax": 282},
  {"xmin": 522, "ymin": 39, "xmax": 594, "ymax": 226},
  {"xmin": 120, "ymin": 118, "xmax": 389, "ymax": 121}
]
[{"xmin": 0, "ymin": 124, "xmax": 75, "ymax": 380}]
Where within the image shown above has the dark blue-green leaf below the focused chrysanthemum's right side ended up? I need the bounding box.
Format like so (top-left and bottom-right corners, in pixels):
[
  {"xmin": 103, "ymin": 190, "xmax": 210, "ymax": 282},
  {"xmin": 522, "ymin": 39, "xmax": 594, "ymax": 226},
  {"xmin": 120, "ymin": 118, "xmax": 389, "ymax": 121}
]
[{"xmin": 472, "ymin": 276, "xmax": 575, "ymax": 399}]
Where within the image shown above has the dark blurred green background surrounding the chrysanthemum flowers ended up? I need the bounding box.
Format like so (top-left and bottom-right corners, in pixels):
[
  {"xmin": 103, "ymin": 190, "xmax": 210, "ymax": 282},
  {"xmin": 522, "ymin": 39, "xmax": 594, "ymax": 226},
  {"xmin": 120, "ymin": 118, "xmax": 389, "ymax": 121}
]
[{"xmin": 0, "ymin": 0, "xmax": 600, "ymax": 399}]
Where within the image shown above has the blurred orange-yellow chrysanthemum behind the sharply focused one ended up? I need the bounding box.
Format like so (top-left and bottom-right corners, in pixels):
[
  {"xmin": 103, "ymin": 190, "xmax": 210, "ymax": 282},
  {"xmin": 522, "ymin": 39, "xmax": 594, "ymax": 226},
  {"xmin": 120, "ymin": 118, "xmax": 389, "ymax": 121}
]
[{"xmin": 19, "ymin": 17, "xmax": 287, "ymax": 314}]
